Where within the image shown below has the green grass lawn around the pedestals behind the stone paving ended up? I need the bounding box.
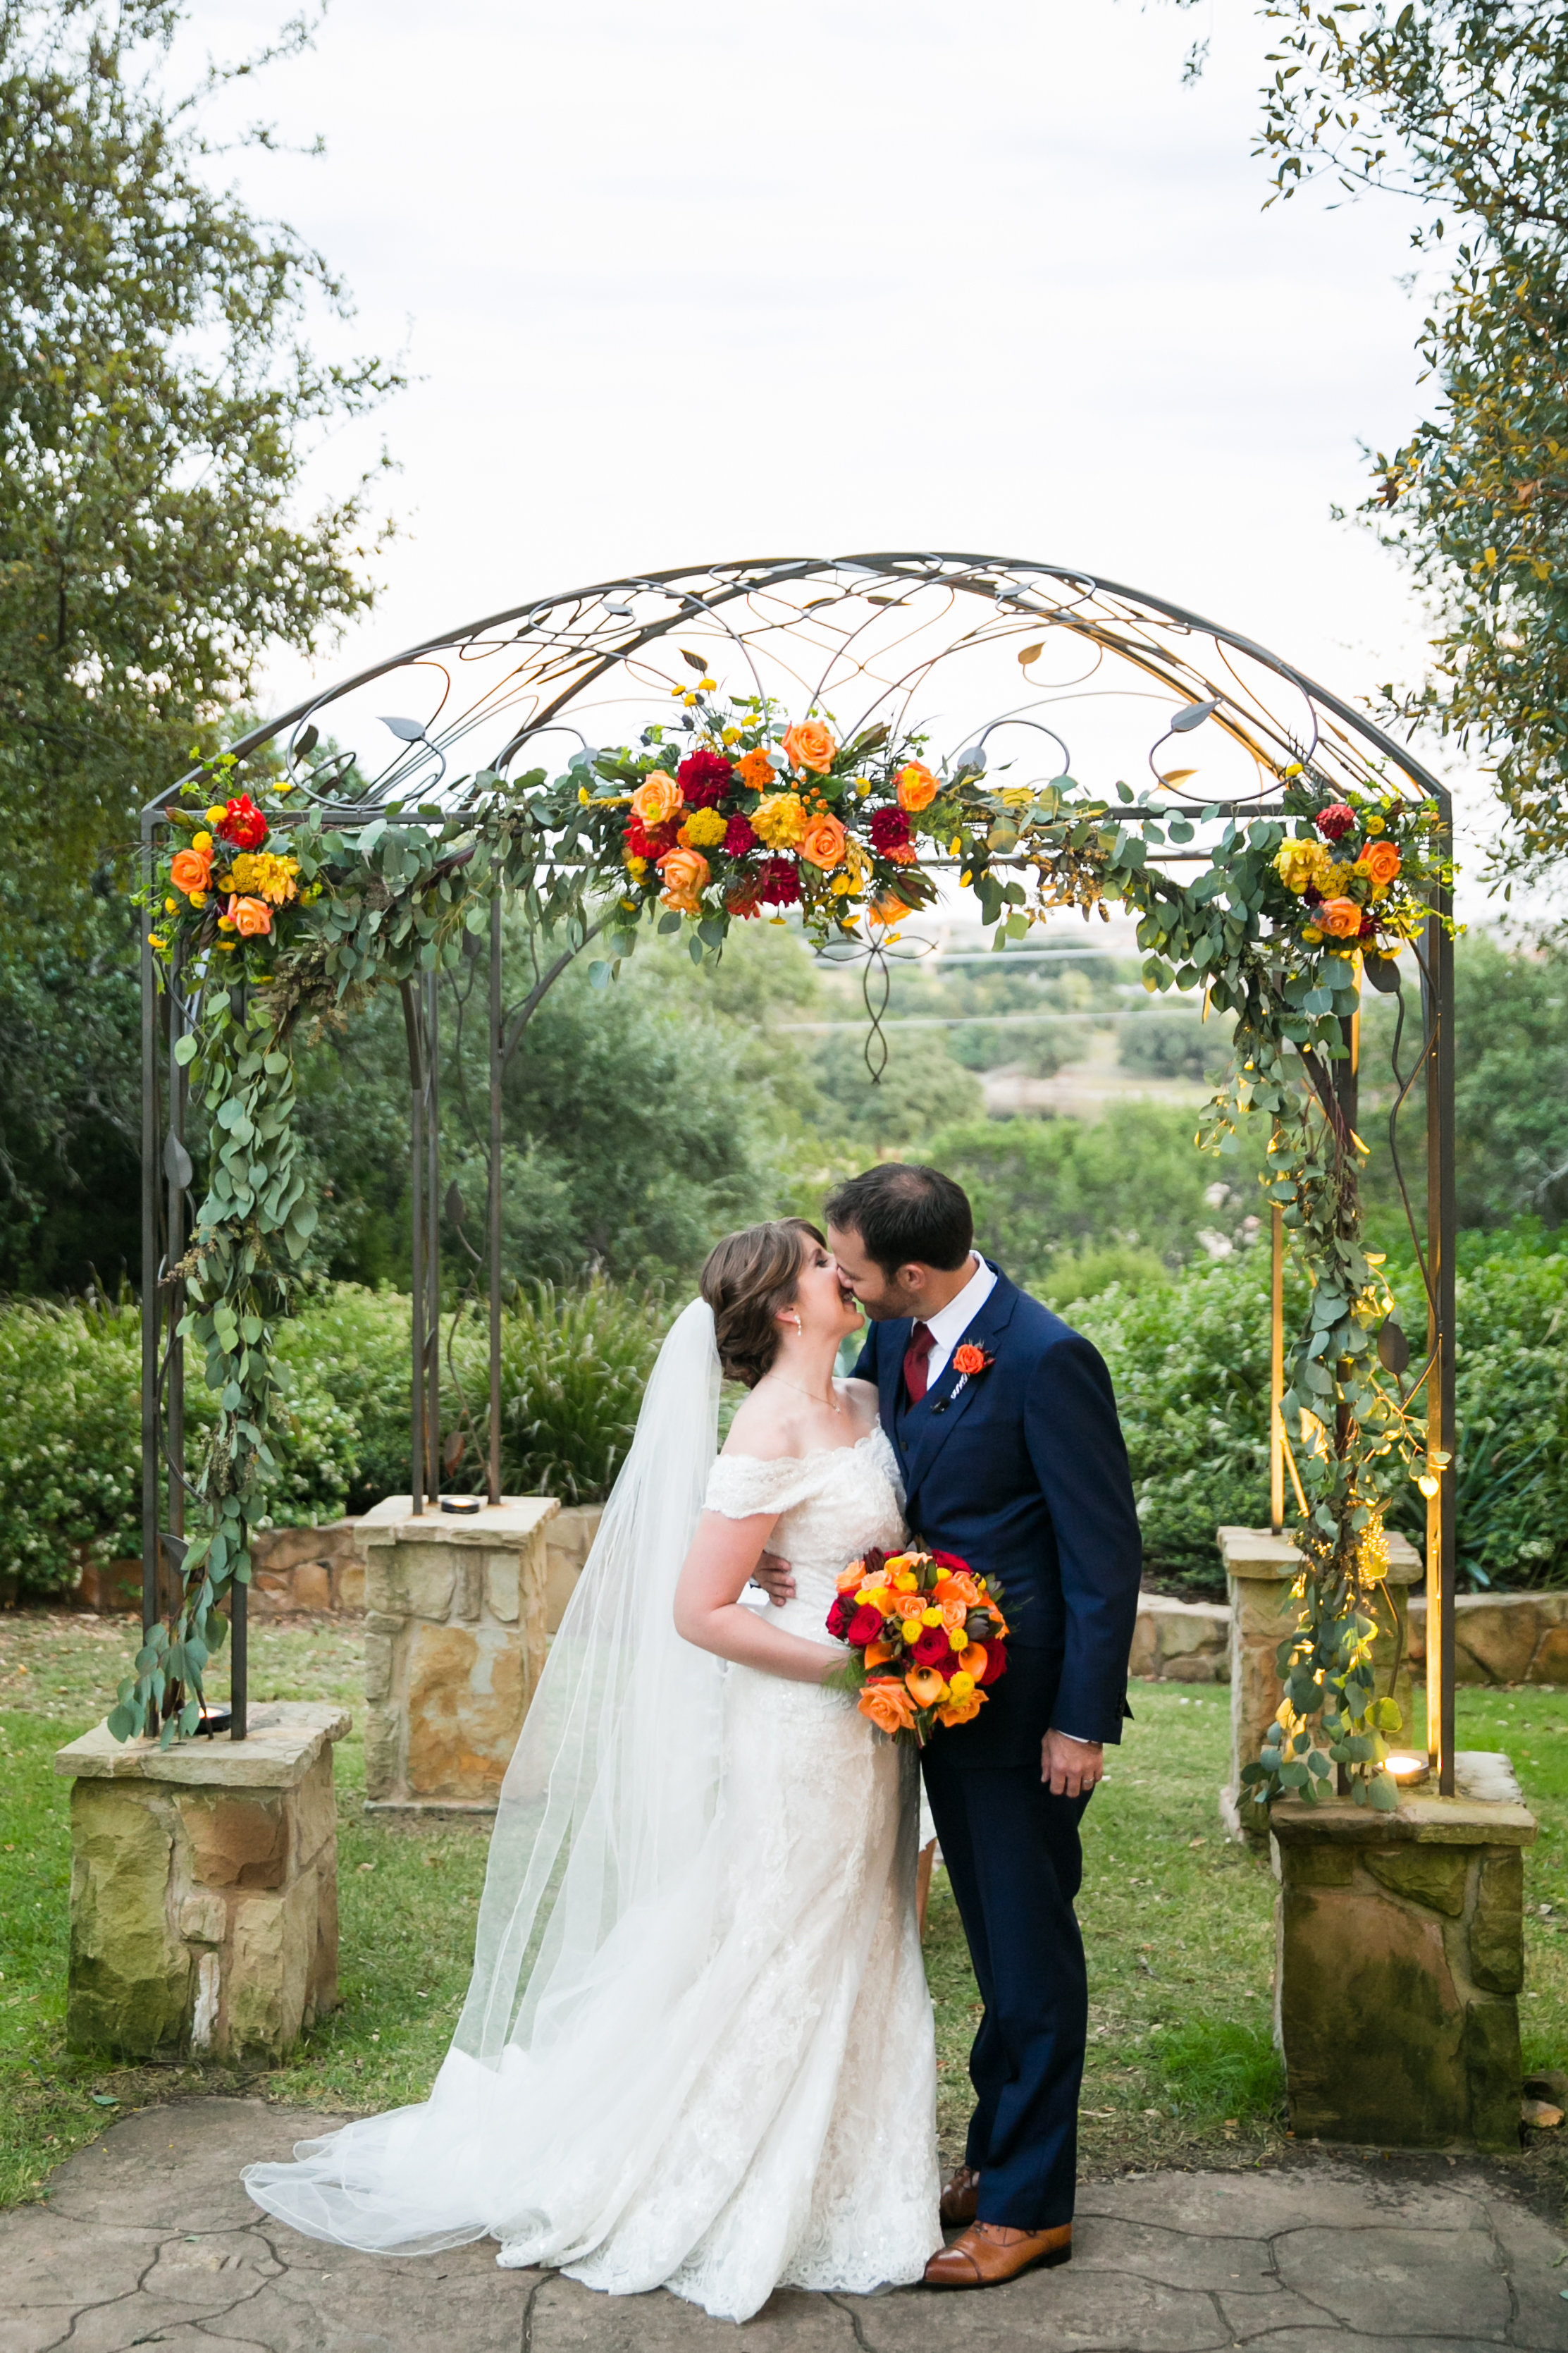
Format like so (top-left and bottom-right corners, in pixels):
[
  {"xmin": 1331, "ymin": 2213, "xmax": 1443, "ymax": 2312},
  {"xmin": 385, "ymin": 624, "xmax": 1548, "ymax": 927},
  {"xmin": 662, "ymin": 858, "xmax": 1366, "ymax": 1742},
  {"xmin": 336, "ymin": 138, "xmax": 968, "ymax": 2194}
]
[{"xmin": 0, "ymin": 1612, "xmax": 1568, "ymax": 2202}]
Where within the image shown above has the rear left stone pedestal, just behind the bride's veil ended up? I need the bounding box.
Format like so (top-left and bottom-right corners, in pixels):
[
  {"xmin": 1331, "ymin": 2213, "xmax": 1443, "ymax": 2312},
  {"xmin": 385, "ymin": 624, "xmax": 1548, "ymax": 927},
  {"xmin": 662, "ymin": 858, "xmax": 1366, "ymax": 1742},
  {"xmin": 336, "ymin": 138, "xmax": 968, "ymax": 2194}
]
[{"xmin": 359, "ymin": 1494, "xmax": 560, "ymax": 1814}]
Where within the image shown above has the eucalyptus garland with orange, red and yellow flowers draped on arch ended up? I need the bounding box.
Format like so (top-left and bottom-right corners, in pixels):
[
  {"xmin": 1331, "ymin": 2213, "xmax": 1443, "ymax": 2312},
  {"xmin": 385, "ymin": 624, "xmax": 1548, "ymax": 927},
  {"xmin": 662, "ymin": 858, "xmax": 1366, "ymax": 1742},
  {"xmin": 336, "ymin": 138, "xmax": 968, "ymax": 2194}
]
[{"xmin": 125, "ymin": 687, "xmax": 1450, "ymax": 1807}]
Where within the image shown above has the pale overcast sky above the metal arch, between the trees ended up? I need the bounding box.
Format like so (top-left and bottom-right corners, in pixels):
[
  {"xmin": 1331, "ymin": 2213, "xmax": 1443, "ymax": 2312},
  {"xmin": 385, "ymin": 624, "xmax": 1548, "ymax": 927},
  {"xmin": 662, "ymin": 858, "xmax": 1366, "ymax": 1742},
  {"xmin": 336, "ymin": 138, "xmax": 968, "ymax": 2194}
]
[{"xmin": 193, "ymin": 0, "xmax": 1532, "ymax": 911}]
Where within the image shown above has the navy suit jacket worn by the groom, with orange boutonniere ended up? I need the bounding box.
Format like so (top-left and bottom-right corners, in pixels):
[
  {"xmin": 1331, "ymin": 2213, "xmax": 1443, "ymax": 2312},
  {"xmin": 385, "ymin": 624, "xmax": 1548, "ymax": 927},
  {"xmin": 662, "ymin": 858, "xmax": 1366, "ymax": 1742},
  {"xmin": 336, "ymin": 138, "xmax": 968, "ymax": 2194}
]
[{"xmin": 856, "ymin": 1261, "xmax": 1142, "ymax": 1762}]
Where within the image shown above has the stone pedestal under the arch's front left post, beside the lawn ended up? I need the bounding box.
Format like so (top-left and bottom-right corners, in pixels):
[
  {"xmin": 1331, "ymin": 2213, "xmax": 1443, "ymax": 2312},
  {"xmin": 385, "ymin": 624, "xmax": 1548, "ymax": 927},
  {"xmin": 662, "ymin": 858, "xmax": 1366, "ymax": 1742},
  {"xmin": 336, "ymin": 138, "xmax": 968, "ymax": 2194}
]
[{"xmin": 54, "ymin": 1699, "xmax": 350, "ymax": 2063}]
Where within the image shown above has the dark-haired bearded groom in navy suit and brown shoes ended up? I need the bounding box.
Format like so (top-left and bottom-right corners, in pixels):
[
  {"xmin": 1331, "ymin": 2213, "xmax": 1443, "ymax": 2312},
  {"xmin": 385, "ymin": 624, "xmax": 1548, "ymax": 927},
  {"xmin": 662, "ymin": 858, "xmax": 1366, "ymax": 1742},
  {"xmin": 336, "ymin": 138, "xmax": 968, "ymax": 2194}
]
[{"xmin": 762, "ymin": 1162, "xmax": 1142, "ymax": 2287}]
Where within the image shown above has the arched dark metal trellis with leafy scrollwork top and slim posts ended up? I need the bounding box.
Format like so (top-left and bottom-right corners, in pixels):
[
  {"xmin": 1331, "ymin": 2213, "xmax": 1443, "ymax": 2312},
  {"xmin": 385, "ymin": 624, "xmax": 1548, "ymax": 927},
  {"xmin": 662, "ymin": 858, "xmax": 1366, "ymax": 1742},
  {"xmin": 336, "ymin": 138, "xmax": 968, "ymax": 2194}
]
[{"xmin": 141, "ymin": 553, "xmax": 1455, "ymax": 1793}]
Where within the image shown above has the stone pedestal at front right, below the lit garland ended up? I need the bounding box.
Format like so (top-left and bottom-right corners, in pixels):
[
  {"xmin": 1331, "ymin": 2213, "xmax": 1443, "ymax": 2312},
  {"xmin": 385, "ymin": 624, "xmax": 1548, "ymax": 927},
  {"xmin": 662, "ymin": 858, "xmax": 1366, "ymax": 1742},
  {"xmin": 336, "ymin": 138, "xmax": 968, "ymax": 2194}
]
[{"xmin": 1274, "ymin": 1757, "xmax": 1535, "ymax": 2151}]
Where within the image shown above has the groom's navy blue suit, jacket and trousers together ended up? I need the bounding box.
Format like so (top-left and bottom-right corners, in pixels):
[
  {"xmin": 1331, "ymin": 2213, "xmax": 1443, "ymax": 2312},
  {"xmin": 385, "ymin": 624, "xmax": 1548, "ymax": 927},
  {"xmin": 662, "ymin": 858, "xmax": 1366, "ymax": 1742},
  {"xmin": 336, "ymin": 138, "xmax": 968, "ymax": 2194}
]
[{"xmin": 856, "ymin": 1273, "xmax": 1142, "ymax": 2230}]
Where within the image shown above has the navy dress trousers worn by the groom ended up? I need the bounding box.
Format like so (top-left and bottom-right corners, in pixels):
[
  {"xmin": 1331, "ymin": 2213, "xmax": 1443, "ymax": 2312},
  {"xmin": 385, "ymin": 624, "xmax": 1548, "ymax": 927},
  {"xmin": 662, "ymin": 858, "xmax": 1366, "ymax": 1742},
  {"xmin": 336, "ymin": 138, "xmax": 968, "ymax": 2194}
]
[{"xmin": 924, "ymin": 1759, "xmax": 1088, "ymax": 2230}]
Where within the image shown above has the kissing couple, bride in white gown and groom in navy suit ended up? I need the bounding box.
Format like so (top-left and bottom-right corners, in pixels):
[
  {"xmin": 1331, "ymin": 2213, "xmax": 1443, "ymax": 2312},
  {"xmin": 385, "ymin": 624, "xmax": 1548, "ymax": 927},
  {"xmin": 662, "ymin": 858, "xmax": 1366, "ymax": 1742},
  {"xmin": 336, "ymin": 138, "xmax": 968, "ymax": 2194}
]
[{"xmin": 245, "ymin": 1162, "xmax": 1140, "ymax": 2320}]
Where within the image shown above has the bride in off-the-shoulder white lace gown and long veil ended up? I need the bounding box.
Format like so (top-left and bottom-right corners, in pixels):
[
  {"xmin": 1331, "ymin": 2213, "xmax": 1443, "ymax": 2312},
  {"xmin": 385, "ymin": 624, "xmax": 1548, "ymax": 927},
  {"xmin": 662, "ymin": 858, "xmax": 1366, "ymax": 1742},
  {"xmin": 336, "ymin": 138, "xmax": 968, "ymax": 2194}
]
[{"xmin": 245, "ymin": 1219, "xmax": 943, "ymax": 2320}]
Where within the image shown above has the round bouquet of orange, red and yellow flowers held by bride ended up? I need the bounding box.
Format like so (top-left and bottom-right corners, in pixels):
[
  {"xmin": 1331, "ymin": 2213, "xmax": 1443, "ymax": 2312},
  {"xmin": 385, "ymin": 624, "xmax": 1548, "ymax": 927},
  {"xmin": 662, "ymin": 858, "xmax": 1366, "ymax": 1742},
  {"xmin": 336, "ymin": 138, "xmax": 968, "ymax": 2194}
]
[{"xmin": 827, "ymin": 1551, "xmax": 1006, "ymax": 1748}]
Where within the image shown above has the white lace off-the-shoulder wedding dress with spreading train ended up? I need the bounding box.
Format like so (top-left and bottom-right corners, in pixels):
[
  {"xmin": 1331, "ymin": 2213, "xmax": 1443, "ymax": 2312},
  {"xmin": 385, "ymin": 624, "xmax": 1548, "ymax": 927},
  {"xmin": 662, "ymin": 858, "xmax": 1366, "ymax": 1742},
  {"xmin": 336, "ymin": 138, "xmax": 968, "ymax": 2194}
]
[{"xmin": 245, "ymin": 1308, "xmax": 943, "ymax": 2320}]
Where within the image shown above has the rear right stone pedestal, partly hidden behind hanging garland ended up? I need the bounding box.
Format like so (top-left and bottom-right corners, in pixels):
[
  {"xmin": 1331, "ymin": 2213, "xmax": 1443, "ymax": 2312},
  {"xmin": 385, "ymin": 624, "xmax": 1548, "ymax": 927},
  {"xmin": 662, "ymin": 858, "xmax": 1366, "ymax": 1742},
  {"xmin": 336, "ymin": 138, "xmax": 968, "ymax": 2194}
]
[{"xmin": 1218, "ymin": 1527, "xmax": 1427, "ymax": 1850}]
